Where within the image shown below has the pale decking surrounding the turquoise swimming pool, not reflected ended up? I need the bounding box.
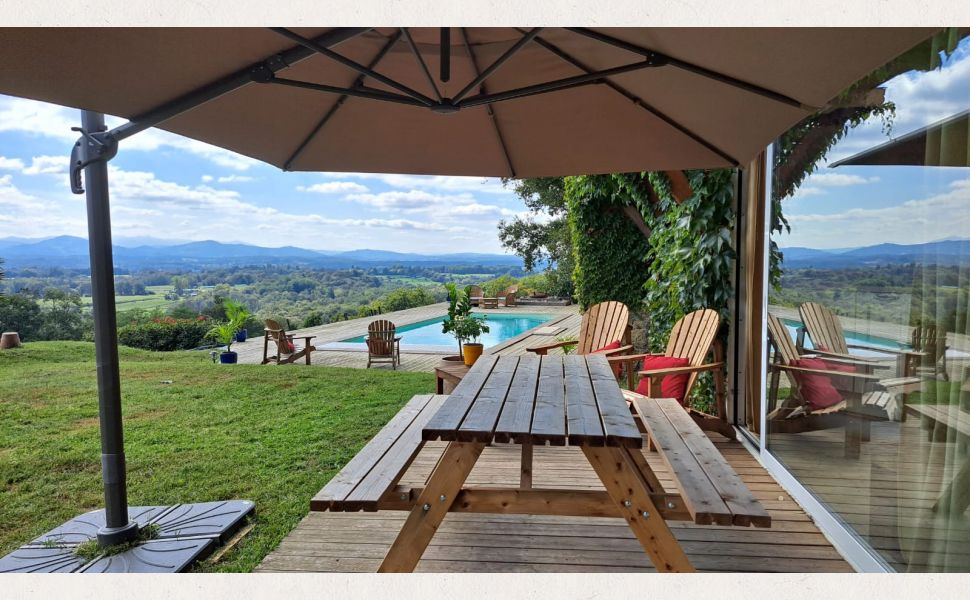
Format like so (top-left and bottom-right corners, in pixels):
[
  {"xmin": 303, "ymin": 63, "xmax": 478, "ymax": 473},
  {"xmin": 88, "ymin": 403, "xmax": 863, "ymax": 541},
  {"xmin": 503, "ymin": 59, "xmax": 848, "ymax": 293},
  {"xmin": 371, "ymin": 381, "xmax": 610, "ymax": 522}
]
[{"xmin": 232, "ymin": 302, "xmax": 580, "ymax": 373}]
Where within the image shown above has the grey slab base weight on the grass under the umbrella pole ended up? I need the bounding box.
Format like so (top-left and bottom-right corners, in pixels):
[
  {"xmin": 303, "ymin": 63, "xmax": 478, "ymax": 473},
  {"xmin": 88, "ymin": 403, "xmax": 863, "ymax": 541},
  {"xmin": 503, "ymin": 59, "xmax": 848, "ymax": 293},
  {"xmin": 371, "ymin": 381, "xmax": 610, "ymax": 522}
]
[{"xmin": 0, "ymin": 500, "xmax": 255, "ymax": 573}]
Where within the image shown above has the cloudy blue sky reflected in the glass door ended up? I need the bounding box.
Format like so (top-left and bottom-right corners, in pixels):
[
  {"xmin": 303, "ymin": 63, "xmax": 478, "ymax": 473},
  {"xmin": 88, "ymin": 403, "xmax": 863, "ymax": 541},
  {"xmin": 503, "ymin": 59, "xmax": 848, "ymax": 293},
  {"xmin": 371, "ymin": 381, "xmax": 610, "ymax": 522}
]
[{"xmin": 777, "ymin": 38, "xmax": 970, "ymax": 248}]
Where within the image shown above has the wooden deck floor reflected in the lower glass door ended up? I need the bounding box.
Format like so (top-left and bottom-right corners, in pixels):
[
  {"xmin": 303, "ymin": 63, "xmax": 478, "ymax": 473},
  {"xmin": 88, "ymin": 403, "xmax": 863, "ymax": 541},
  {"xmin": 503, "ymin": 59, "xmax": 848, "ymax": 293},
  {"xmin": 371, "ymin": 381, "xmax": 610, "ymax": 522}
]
[{"xmin": 768, "ymin": 415, "xmax": 970, "ymax": 573}]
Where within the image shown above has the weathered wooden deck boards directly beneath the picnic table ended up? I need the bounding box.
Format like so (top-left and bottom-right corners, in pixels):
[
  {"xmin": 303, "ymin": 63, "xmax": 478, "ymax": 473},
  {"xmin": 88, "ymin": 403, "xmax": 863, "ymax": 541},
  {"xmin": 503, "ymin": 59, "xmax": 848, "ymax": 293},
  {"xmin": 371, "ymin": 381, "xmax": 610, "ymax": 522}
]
[{"xmin": 256, "ymin": 434, "xmax": 852, "ymax": 573}]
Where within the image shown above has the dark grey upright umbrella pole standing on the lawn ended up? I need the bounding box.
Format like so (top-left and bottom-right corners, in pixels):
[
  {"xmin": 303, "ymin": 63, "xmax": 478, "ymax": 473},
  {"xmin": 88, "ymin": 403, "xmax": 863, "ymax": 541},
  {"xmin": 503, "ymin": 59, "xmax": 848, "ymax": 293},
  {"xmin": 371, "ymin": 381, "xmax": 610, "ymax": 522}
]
[{"xmin": 78, "ymin": 110, "xmax": 138, "ymax": 548}]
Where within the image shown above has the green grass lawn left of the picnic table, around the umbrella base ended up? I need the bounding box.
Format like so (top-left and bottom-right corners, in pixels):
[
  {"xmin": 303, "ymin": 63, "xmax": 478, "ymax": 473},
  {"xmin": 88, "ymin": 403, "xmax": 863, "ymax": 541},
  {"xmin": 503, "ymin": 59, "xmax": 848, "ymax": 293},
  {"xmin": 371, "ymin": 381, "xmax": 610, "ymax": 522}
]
[{"xmin": 0, "ymin": 342, "xmax": 434, "ymax": 571}]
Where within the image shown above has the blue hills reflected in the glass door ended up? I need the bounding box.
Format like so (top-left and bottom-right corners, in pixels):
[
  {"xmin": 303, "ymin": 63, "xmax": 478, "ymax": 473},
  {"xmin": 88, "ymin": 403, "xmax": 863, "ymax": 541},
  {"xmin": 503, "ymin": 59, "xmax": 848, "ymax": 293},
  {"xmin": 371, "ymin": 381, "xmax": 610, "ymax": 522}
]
[{"xmin": 781, "ymin": 239, "xmax": 970, "ymax": 269}]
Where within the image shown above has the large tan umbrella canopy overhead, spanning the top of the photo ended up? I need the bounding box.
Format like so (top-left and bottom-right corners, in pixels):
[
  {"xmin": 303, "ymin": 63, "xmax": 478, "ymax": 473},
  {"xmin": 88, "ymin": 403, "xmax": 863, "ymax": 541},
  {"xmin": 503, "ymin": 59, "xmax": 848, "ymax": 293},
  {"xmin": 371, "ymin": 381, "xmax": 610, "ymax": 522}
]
[{"xmin": 0, "ymin": 27, "xmax": 935, "ymax": 177}]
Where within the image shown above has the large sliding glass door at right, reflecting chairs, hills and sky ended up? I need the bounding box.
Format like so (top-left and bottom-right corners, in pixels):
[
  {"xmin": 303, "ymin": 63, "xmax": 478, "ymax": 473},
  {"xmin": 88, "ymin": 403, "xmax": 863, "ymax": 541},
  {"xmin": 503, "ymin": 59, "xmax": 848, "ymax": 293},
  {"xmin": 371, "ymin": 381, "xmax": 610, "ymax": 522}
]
[{"xmin": 749, "ymin": 29, "xmax": 970, "ymax": 572}]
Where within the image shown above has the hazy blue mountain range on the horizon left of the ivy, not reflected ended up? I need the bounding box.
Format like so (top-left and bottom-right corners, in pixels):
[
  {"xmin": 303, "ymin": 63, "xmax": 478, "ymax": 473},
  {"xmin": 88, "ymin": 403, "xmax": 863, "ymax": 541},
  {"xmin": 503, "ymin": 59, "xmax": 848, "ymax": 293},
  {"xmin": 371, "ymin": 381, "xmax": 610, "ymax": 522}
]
[{"xmin": 0, "ymin": 236, "xmax": 522, "ymax": 270}]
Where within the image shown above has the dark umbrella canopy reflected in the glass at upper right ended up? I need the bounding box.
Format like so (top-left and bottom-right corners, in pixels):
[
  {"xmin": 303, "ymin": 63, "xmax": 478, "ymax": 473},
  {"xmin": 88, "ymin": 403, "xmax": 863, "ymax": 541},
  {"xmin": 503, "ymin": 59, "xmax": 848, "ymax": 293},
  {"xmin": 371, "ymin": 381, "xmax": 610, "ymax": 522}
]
[{"xmin": 829, "ymin": 110, "xmax": 970, "ymax": 167}]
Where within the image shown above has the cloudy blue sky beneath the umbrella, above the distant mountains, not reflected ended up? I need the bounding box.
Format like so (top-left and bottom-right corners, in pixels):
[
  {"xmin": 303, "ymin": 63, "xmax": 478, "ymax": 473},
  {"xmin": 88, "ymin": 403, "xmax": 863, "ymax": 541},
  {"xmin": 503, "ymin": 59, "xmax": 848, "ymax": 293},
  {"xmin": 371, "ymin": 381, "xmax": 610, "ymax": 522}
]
[{"xmin": 0, "ymin": 96, "xmax": 526, "ymax": 253}]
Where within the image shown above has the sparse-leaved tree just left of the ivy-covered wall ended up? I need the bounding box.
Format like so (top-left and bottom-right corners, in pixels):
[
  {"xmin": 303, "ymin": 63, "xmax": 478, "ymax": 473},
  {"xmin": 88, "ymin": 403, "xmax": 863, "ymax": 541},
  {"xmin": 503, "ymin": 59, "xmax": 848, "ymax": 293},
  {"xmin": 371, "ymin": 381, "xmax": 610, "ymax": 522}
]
[{"xmin": 498, "ymin": 177, "xmax": 574, "ymax": 296}]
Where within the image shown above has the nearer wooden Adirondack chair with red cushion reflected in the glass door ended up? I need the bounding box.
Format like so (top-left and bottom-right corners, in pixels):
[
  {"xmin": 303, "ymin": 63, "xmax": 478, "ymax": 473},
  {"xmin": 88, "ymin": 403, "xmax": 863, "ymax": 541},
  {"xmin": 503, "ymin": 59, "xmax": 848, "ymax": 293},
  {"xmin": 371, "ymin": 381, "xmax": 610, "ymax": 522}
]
[{"xmin": 768, "ymin": 313, "xmax": 919, "ymax": 458}]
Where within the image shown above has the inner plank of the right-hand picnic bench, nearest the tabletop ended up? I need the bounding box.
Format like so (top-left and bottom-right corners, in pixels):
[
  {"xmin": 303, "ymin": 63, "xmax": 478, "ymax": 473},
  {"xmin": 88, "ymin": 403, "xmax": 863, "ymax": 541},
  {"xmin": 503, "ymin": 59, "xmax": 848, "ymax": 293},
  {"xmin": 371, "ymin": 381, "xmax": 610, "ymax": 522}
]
[{"xmin": 634, "ymin": 398, "xmax": 734, "ymax": 525}]
